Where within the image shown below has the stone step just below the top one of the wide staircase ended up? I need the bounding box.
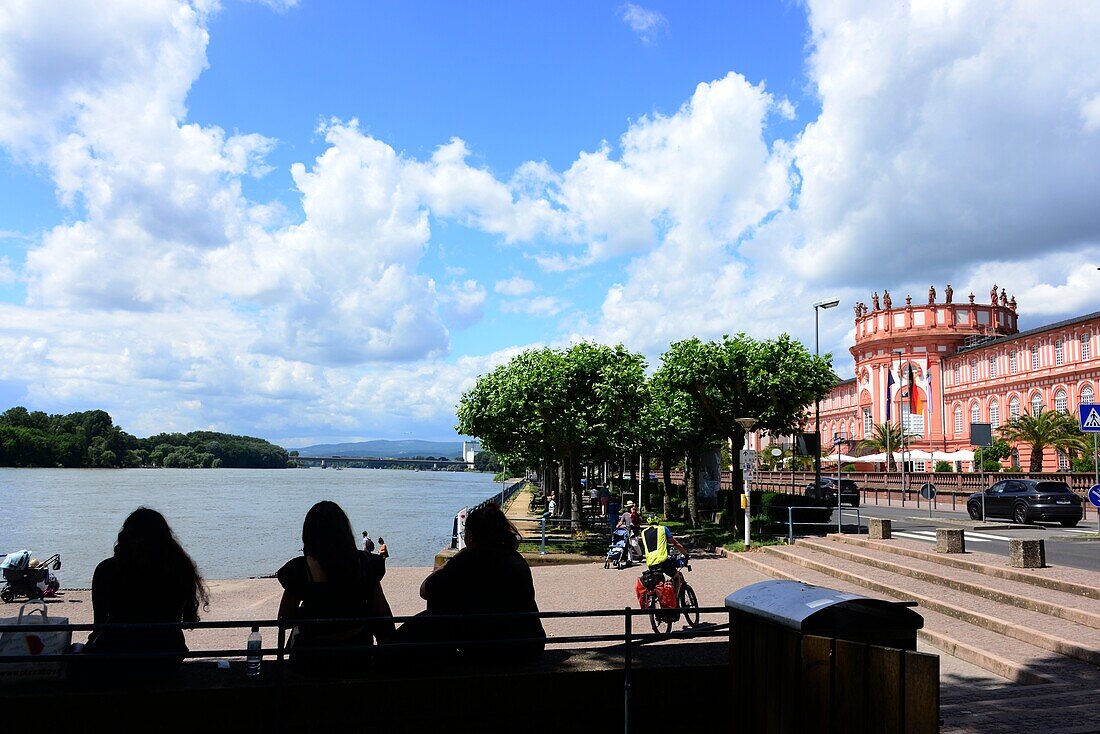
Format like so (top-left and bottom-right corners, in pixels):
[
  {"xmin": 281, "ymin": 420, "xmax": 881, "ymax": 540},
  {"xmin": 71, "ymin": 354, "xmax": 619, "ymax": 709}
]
[{"xmin": 798, "ymin": 538, "xmax": 1100, "ymax": 629}]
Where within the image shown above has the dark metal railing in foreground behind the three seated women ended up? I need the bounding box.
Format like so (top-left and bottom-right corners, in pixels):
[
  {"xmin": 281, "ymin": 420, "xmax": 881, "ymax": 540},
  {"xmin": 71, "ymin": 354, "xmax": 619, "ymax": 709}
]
[{"xmin": 0, "ymin": 606, "xmax": 729, "ymax": 733}]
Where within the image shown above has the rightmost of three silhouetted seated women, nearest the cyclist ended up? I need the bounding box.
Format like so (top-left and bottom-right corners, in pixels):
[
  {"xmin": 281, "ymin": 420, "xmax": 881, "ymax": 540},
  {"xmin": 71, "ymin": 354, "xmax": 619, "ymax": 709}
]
[{"xmin": 413, "ymin": 504, "xmax": 546, "ymax": 661}]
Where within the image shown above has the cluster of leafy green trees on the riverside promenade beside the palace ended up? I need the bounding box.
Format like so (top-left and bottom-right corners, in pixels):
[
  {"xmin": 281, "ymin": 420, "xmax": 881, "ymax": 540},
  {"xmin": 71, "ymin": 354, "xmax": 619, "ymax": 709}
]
[{"xmin": 457, "ymin": 333, "xmax": 837, "ymax": 526}]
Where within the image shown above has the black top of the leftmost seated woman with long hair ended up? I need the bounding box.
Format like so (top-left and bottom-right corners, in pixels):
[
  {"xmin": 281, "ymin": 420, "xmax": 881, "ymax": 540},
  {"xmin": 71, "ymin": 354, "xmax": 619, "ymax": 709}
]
[{"xmin": 87, "ymin": 557, "xmax": 195, "ymax": 653}]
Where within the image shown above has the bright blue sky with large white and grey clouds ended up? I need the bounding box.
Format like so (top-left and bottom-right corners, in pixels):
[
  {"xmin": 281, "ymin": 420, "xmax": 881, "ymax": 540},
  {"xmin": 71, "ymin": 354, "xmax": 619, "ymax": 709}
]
[{"xmin": 0, "ymin": 0, "xmax": 1100, "ymax": 447}]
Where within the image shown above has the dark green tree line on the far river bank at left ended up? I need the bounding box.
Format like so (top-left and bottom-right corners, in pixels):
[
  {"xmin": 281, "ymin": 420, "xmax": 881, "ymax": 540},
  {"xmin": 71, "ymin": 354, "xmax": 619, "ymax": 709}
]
[{"xmin": 0, "ymin": 406, "xmax": 288, "ymax": 469}]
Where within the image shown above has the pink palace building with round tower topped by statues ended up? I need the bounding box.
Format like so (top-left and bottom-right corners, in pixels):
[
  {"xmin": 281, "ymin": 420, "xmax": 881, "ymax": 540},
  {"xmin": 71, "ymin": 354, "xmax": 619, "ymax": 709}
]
[{"xmin": 792, "ymin": 285, "xmax": 1100, "ymax": 471}]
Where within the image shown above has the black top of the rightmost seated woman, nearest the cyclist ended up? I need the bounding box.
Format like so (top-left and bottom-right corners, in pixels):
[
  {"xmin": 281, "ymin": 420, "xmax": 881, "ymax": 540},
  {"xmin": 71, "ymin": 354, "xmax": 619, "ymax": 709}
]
[{"xmin": 425, "ymin": 548, "xmax": 546, "ymax": 655}]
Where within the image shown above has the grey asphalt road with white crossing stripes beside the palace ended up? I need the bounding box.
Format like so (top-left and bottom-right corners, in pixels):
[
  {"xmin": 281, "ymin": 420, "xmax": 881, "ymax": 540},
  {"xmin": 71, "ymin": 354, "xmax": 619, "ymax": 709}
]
[{"xmin": 833, "ymin": 500, "xmax": 1100, "ymax": 571}]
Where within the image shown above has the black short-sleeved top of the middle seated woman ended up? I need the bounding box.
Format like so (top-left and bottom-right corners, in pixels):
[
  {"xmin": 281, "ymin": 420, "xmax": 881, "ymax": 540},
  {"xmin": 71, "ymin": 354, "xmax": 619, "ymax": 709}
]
[{"xmin": 275, "ymin": 550, "xmax": 386, "ymax": 645}]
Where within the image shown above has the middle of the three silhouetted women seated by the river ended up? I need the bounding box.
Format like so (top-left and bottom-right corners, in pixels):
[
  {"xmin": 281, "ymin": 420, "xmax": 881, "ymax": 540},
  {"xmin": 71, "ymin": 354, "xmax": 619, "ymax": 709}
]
[{"xmin": 276, "ymin": 501, "xmax": 394, "ymax": 675}]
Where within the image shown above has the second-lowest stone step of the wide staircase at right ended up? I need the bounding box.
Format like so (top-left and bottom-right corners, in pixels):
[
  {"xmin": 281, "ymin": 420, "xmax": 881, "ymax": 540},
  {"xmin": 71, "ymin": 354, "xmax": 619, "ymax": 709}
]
[{"xmin": 767, "ymin": 546, "xmax": 1100, "ymax": 666}]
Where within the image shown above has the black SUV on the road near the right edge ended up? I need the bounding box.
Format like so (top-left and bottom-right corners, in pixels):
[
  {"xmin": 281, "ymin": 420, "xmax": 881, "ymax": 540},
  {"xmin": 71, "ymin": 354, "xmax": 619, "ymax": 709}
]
[{"xmin": 966, "ymin": 479, "xmax": 1085, "ymax": 527}]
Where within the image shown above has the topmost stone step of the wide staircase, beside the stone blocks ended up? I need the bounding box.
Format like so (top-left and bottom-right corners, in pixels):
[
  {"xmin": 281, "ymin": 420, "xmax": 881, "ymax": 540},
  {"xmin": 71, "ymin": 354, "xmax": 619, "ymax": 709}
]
[{"xmin": 826, "ymin": 534, "xmax": 1100, "ymax": 600}]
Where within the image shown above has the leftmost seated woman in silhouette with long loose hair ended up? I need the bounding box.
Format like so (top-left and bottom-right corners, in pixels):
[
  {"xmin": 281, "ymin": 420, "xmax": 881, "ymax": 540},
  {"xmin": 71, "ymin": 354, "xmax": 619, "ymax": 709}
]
[{"xmin": 76, "ymin": 507, "xmax": 210, "ymax": 676}]
